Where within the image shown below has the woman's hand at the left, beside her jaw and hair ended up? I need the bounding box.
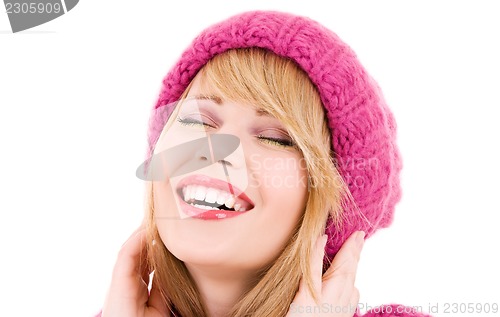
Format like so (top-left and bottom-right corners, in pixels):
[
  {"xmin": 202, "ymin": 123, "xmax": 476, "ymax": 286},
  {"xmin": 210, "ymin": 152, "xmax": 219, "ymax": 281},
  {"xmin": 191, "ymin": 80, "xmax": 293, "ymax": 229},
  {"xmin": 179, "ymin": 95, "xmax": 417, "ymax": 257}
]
[{"xmin": 101, "ymin": 225, "xmax": 169, "ymax": 317}]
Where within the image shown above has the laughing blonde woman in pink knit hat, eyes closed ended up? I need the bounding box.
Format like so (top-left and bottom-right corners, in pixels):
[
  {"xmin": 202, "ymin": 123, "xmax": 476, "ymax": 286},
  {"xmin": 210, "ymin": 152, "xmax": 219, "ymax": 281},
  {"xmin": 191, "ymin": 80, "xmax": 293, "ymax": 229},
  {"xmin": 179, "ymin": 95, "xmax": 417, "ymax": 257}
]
[{"xmin": 98, "ymin": 11, "xmax": 430, "ymax": 317}]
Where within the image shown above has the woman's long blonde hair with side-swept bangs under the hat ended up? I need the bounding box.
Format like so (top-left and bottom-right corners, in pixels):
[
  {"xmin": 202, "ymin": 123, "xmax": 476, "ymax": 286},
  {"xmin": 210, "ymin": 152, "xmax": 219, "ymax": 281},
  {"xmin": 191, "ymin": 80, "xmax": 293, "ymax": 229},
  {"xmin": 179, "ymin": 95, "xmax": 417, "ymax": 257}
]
[{"xmin": 145, "ymin": 48, "xmax": 350, "ymax": 317}]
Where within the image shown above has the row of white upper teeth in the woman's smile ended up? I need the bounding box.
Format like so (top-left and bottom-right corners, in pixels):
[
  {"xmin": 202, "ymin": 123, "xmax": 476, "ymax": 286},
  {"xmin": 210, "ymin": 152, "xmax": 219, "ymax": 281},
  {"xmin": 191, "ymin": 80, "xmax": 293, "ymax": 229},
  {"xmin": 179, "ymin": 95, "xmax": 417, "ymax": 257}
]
[{"xmin": 182, "ymin": 185, "xmax": 245, "ymax": 211}]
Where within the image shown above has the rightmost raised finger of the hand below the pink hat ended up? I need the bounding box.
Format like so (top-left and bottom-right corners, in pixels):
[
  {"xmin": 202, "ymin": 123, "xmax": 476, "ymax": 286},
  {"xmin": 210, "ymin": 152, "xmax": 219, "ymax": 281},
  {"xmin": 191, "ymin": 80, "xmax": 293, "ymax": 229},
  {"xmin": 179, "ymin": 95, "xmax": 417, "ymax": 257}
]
[{"xmin": 323, "ymin": 231, "xmax": 365, "ymax": 296}]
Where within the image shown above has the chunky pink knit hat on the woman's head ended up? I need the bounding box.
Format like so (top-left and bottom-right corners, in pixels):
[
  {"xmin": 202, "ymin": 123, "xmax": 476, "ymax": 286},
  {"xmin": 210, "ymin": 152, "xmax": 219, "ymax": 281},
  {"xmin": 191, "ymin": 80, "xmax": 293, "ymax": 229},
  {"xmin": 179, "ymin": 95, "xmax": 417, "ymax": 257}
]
[{"xmin": 147, "ymin": 11, "xmax": 402, "ymax": 260}]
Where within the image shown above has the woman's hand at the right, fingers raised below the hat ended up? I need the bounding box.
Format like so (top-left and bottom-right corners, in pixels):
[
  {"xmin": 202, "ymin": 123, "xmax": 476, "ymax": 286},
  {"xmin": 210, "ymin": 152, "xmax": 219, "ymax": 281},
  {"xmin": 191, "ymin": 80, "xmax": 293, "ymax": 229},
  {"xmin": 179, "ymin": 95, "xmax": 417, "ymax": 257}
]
[{"xmin": 287, "ymin": 231, "xmax": 365, "ymax": 317}]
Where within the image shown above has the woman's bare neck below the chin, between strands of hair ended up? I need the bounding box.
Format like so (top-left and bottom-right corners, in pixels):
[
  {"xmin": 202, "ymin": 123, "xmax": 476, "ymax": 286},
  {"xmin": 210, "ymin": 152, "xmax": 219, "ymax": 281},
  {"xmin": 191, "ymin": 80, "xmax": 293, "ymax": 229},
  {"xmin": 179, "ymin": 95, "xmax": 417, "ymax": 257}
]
[{"xmin": 186, "ymin": 263, "xmax": 254, "ymax": 317}]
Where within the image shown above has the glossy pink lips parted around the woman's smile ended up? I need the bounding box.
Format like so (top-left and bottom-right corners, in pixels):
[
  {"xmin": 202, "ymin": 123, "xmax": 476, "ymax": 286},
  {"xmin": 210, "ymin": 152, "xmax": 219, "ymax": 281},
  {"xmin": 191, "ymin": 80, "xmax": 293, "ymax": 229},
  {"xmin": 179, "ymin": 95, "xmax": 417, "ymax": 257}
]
[{"xmin": 177, "ymin": 175, "xmax": 254, "ymax": 220}]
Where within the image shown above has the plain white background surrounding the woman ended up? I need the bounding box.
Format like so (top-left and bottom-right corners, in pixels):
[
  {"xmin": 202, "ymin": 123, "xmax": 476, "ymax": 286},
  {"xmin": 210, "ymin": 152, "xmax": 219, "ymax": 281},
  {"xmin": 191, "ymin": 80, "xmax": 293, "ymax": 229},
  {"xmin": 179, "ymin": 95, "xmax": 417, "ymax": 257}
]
[{"xmin": 0, "ymin": 0, "xmax": 500, "ymax": 316}]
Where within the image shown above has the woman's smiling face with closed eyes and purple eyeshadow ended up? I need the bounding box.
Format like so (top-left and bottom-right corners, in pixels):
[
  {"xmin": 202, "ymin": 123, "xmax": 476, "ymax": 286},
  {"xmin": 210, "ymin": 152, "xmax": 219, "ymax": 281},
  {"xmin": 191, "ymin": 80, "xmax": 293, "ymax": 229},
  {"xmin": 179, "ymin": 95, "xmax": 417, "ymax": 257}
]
[{"xmin": 154, "ymin": 78, "xmax": 307, "ymax": 271}]
